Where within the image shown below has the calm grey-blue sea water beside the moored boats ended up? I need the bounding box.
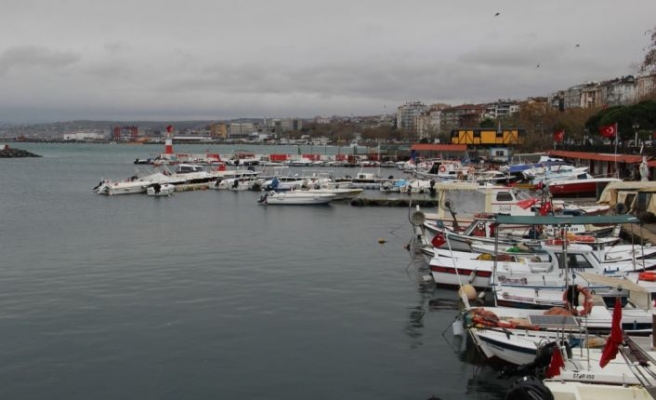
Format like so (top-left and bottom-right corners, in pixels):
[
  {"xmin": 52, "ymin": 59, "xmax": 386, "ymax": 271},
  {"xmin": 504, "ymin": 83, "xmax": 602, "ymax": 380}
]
[{"xmin": 0, "ymin": 144, "xmax": 507, "ymax": 400}]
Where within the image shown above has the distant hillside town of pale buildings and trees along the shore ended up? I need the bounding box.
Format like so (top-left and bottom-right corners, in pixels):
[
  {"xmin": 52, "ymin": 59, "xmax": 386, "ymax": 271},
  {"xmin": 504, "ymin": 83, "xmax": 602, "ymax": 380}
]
[{"xmin": 0, "ymin": 74, "xmax": 656, "ymax": 151}]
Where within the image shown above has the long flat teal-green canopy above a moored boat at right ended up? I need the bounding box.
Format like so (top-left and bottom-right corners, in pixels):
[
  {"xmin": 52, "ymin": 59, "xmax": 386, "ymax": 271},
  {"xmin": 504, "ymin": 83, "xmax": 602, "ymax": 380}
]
[{"xmin": 495, "ymin": 214, "xmax": 640, "ymax": 225}]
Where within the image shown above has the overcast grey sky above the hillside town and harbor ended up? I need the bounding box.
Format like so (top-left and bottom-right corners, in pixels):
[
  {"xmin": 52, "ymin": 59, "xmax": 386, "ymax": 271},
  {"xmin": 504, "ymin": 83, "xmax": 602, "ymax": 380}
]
[{"xmin": 0, "ymin": 0, "xmax": 656, "ymax": 122}]
